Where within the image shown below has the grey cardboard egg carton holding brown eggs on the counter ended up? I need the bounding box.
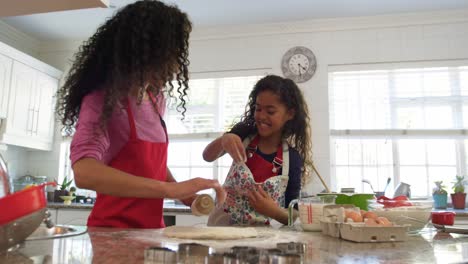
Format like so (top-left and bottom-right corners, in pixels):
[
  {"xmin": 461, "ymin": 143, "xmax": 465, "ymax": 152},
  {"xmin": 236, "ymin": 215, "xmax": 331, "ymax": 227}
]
[{"xmin": 320, "ymin": 205, "xmax": 408, "ymax": 242}]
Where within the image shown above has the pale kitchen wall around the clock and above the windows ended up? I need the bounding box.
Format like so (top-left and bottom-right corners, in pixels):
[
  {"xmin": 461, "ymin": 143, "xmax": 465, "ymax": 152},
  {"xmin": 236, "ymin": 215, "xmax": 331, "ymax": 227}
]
[{"xmin": 0, "ymin": 10, "xmax": 468, "ymax": 193}]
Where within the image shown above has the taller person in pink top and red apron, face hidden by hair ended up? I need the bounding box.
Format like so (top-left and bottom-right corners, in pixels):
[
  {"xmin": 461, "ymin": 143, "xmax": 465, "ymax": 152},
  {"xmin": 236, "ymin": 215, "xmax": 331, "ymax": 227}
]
[{"xmin": 57, "ymin": 0, "xmax": 223, "ymax": 228}]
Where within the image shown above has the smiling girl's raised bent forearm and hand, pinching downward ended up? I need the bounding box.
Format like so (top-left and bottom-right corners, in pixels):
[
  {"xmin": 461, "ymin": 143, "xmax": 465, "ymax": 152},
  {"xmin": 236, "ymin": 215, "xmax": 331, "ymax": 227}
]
[{"xmin": 203, "ymin": 133, "xmax": 247, "ymax": 162}]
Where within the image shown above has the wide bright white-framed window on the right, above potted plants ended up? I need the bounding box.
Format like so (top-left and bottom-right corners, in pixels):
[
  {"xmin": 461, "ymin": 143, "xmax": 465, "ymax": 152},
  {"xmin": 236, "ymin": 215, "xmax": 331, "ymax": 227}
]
[{"xmin": 329, "ymin": 61, "xmax": 468, "ymax": 197}]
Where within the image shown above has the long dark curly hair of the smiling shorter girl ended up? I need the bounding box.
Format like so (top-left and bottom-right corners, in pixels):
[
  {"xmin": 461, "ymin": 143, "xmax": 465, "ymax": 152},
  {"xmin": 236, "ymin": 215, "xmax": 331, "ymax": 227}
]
[{"xmin": 229, "ymin": 75, "xmax": 312, "ymax": 185}]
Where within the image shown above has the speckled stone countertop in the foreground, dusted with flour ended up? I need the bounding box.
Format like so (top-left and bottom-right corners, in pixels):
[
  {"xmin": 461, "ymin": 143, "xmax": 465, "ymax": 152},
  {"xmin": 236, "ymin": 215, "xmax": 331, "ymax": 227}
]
[{"xmin": 0, "ymin": 226, "xmax": 468, "ymax": 263}]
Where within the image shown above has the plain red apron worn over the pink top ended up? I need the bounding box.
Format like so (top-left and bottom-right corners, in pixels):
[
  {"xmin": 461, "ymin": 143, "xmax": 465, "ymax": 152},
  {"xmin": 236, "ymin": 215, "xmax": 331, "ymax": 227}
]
[{"xmin": 88, "ymin": 100, "xmax": 168, "ymax": 228}]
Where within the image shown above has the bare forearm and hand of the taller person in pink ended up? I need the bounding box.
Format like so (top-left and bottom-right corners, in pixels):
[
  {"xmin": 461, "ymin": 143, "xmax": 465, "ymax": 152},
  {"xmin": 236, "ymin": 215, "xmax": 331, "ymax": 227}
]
[{"xmin": 73, "ymin": 158, "xmax": 224, "ymax": 199}]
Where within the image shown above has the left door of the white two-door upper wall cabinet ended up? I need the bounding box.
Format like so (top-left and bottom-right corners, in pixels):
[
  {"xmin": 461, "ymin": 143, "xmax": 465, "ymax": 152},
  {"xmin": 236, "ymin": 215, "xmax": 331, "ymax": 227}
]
[{"xmin": 5, "ymin": 61, "xmax": 36, "ymax": 140}]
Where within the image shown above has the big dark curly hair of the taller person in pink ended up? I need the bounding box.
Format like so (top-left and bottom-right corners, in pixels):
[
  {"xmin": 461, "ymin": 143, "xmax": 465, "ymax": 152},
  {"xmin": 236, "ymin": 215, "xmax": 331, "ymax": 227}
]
[{"xmin": 56, "ymin": 0, "xmax": 192, "ymax": 134}]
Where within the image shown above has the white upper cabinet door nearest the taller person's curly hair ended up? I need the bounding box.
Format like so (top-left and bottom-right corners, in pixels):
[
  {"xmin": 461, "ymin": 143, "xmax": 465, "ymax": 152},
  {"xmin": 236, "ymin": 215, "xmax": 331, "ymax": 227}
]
[{"xmin": 32, "ymin": 72, "xmax": 58, "ymax": 145}]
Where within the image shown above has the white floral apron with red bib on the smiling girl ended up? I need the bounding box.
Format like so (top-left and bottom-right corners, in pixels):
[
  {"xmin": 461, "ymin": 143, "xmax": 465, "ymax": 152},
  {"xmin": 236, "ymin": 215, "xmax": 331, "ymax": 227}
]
[{"xmin": 208, "ymin": 137, "xmax": 289, "ymax": 226}]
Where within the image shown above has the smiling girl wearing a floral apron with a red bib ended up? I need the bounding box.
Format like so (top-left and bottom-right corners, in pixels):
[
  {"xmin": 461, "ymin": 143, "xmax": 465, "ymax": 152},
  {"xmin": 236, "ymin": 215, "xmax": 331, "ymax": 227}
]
[{"xmin": 203, "ymin": 75, "xmax": 311, "ymax": 225}]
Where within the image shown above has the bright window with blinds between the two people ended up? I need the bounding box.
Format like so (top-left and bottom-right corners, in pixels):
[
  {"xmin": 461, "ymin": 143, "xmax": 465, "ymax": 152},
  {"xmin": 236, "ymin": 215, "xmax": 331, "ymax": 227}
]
[{"xmin": 165, "ymin": 75, "xmax": 263, "ymax": 186}]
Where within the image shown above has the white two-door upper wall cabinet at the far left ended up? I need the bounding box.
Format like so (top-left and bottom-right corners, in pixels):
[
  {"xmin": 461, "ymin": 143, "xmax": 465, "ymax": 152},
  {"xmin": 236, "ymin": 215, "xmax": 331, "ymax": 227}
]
[{"xmin": 1, "ymin": 61, "xmax": 58, "ymax": 150}]
